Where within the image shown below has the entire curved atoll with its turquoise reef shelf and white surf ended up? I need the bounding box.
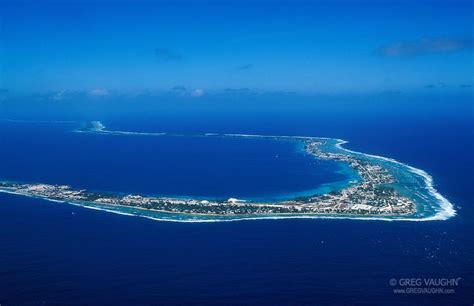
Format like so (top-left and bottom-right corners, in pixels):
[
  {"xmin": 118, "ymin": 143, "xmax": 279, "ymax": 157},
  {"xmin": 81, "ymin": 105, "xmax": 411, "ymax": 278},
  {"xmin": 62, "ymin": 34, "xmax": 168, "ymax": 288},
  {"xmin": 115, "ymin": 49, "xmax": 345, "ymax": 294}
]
[{"xmin": 0, "ymin": 121, "xmax": 454, "ymax": 220}]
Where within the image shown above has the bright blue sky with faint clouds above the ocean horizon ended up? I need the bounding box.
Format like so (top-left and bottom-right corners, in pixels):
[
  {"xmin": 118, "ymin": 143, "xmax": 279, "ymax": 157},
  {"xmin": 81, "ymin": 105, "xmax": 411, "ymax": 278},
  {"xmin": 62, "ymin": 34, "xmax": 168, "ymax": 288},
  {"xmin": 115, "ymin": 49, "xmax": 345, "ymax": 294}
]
[{"xmin": 0, "ymin": 0, "xmax": 474, "ymax": 100}]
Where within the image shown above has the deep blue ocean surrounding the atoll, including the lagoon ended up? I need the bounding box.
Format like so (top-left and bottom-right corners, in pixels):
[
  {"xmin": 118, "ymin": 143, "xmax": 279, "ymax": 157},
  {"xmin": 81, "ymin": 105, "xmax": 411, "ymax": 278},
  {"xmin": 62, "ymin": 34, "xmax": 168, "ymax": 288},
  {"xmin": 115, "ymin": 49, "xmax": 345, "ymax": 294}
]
[{"xmin": 0, "ymin": 94, "xmax": 474, "ymax": 306}]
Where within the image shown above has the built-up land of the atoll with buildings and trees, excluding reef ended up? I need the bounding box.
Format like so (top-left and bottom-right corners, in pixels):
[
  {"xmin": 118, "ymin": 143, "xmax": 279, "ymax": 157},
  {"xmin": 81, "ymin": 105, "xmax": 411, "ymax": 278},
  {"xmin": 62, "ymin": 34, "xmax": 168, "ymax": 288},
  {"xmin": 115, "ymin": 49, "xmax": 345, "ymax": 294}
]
[{"xmin": 0, "ymin": 139, "xmax": 416, "ymax": 216}]
